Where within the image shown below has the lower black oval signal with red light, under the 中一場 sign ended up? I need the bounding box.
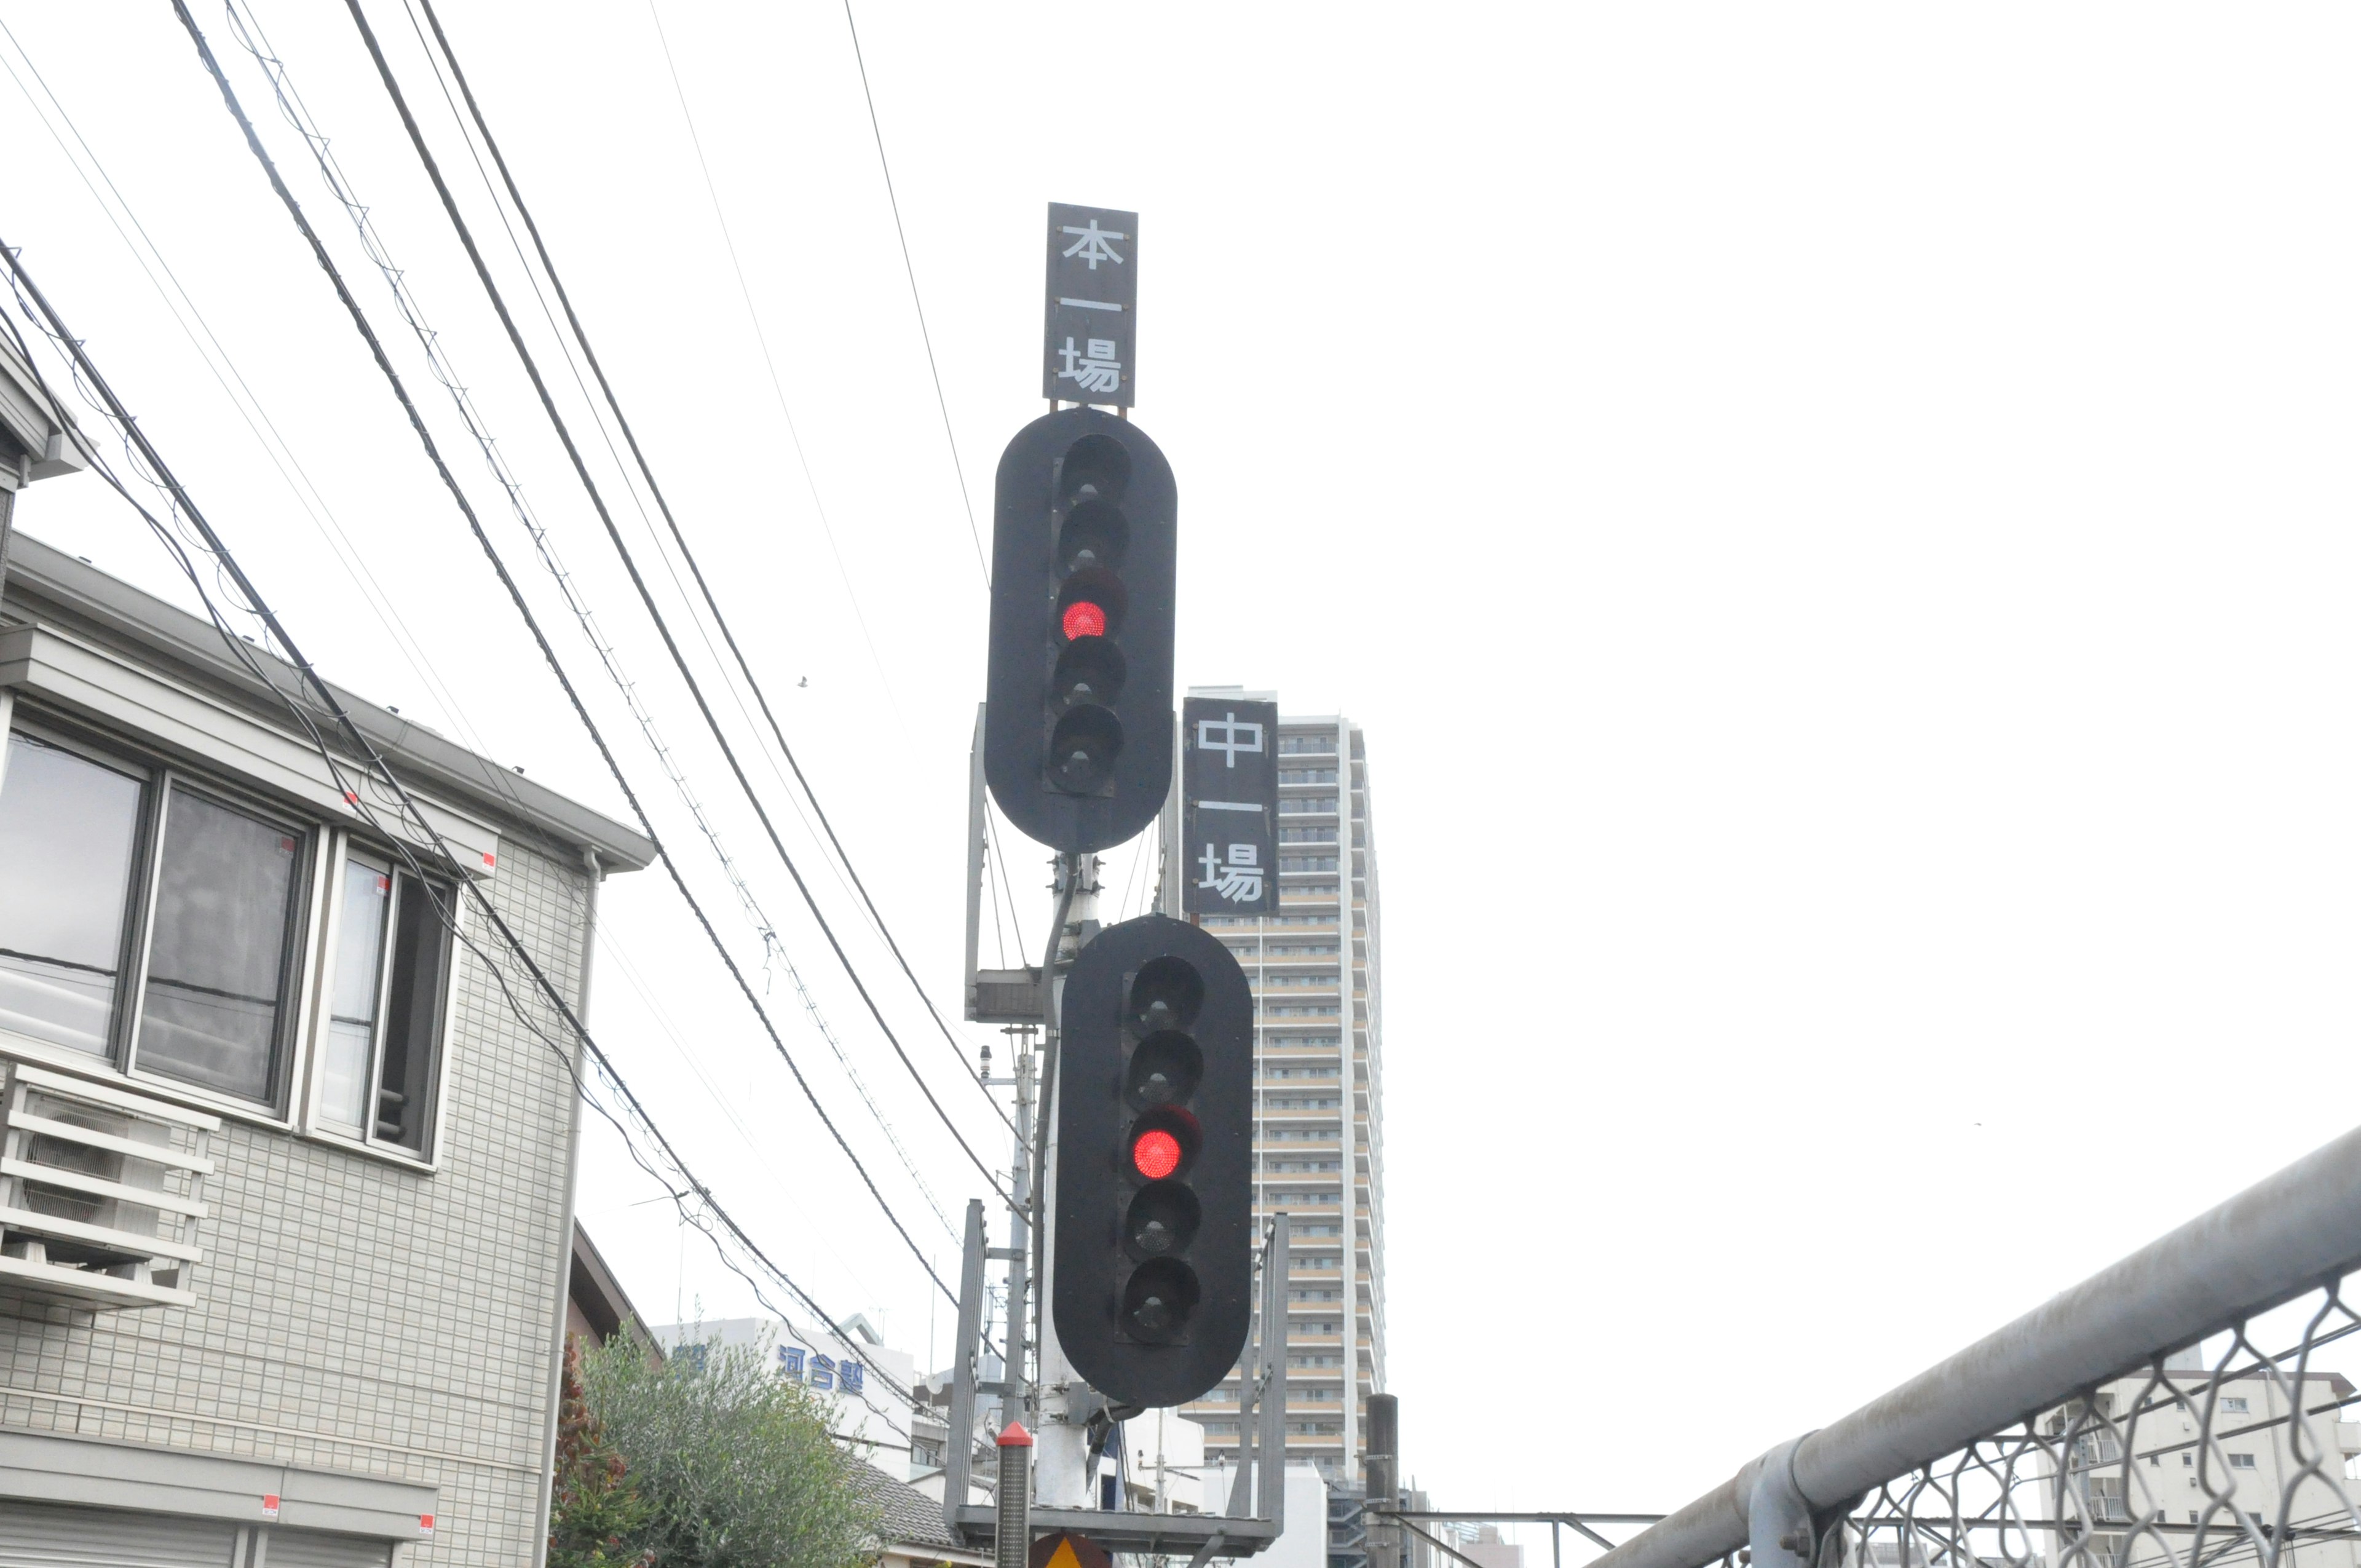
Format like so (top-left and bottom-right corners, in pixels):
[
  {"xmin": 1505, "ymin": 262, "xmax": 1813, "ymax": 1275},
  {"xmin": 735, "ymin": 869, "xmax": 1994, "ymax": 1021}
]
[{"xmin": 1051, "ymin": 914, "xmax": 1254, "ymax": 1405}]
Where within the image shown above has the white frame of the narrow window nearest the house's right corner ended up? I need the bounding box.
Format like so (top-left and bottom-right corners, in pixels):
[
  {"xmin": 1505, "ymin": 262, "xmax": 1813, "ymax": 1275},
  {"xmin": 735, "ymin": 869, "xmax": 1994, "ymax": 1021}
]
[{"xmin": 300, "ymin": 829, "xmax": 467, "ymax": 1171}]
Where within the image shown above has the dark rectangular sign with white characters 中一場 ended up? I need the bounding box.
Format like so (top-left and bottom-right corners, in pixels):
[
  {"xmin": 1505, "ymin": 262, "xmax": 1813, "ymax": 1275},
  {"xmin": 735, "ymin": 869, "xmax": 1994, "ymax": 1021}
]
[{"xmin": 1180, "ymin": 697, "xmax": 1279, "ymax": 914}]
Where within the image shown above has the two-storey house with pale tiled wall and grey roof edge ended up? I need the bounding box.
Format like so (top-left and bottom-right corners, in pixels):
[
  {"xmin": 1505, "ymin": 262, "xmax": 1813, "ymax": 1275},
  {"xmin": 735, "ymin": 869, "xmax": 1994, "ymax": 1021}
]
[{"xmin": 0, "ymin": 362, "xmax": 654, "ymax": 1568}]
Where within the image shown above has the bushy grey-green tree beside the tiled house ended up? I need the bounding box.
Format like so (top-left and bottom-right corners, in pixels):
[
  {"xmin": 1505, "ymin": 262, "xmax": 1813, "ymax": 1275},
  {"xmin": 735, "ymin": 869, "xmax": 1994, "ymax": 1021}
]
[{"xmin": 581, "ymin": 1334, "xmax": 883, "ymax": 1568}]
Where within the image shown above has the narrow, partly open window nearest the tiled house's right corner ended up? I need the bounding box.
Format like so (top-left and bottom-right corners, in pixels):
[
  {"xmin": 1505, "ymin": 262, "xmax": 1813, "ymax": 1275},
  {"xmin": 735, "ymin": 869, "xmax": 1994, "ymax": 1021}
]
[{"xmin": 318, "ymin": 845, "xmax": 451, "ymax": 1155}]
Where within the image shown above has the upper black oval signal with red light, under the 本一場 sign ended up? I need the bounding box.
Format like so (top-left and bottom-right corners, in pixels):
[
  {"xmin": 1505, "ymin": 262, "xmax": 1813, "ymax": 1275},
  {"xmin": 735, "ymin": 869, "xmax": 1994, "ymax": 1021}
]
[{"xmin": 984, "ymin": 408, "xmax": 1178, "ymax": 852}]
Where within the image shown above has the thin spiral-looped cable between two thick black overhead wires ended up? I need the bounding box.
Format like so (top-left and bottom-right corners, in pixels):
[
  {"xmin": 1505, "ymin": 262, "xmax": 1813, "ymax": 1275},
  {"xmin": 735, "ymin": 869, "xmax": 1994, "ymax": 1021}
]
[{"xmin": 210, "ymin": 5, "xmax": 956, "ymax": 1235}]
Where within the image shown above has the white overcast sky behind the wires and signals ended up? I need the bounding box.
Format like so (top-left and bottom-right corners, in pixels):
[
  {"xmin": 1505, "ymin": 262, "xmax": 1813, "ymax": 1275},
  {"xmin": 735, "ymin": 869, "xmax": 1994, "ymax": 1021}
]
[{"xmin": 0, "ymin": 0, "xmax": 2361, "ymax": 1539}]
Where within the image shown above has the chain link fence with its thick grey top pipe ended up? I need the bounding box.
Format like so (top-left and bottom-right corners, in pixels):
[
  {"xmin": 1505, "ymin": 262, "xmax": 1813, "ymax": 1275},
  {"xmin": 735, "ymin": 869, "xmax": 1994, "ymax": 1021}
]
[{"xmin": 1599, "ymin": 1131, "xmax": 2361, "ymax": 1568}]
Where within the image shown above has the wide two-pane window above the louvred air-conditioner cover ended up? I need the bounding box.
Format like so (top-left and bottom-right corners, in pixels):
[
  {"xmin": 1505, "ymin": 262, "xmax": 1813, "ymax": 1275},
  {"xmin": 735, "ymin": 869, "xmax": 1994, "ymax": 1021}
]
[{"xmin": 0, "ymin": 730, "xmax": 312, "ymax": 1107}]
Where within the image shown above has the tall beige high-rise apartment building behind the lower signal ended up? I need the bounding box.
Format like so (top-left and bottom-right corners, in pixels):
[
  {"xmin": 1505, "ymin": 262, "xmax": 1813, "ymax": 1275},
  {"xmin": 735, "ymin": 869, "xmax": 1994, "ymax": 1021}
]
[{"xmin": 1188, "ymin": 703, "xmax": 1386, "ymax": 1483}]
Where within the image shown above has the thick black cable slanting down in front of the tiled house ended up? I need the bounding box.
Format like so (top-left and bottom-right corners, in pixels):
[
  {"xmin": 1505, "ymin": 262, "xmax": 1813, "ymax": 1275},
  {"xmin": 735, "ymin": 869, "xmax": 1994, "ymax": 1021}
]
[{"xmin": 0, "ymin": 248, "xmax": 933, "ymax": 1417}]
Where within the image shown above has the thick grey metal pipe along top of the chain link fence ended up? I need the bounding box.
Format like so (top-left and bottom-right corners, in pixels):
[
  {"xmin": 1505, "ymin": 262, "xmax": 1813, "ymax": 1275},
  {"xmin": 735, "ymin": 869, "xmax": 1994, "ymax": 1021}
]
[{"xmin": 1594, "ymin": 1129, "xmax": 2361, "ymax": 1568}]
